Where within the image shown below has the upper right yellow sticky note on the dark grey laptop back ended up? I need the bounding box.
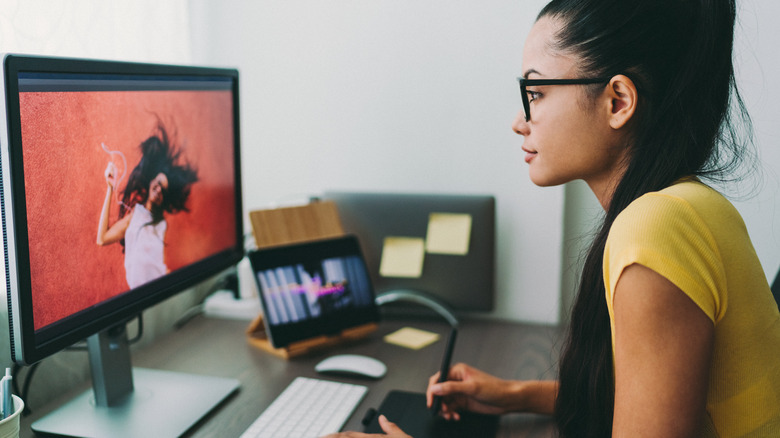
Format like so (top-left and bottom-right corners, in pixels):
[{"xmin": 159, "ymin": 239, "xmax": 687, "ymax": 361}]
[{"xmin": 425, "ymin": 213, "xmax": 471, "ymax": 255}]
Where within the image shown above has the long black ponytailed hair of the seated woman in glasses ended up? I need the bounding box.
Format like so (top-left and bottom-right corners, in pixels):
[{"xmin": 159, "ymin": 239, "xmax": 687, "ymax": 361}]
[{"xmin": 539, "ymin": 0, "xmax": 750, "ymax": 437}]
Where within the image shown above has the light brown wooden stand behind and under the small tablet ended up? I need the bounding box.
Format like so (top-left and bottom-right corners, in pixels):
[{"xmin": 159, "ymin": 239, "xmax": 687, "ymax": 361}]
[{"xmin": 246, "ymin": 201, "xmax": 377, "ymax": 359}]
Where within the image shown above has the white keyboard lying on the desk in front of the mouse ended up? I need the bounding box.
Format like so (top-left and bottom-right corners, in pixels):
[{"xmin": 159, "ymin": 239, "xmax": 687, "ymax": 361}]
[{"xmin": 241, "ymin": 377, "xmax": 368, "ymax": 438}]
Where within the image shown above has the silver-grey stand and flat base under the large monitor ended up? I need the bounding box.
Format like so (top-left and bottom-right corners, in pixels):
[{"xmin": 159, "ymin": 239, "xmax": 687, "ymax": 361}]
[{"xmin": 32, "ymin": 324, "xmax": 239, "ymax": 438}]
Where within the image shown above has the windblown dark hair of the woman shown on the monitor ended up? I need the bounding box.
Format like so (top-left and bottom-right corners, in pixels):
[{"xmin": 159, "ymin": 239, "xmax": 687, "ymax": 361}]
[{"xmin": 119, "ymin": 120, "xmax": 198, "ymax": 224}]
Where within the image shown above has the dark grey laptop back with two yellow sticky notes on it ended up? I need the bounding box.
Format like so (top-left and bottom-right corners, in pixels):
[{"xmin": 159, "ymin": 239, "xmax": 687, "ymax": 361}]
[{"xmin": 321, "ymin": 191, "xmax": 495, "ymax": 313}]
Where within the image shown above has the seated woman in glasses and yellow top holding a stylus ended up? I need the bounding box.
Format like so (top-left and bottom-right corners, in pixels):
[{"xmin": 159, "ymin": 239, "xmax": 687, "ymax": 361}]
[{"xmin": 326, "ymin": 0, "xmax": 780, "ymax": 437}]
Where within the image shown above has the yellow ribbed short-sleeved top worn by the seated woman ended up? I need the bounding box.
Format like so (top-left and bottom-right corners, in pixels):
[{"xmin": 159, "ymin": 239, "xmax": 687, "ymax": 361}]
[{"xmin": 604, "ymin": 179, "xmax": 780, "ymax": 437}]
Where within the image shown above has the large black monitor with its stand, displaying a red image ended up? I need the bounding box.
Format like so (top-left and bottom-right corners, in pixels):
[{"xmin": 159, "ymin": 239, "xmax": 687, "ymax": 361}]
[{"xmin": 0, "ymin": 55, "xmax": 244, "ymax": 437}]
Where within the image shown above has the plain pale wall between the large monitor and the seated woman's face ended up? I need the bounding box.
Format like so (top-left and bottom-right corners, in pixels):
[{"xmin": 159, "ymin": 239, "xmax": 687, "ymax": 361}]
[{"xmin": 190, "ymin": 0, "xmax": 563, "ymax": 323}]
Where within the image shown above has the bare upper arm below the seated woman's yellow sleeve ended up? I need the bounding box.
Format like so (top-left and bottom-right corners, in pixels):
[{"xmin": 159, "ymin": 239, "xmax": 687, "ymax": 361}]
[{"xmin": 612, "ymin": 264, "xmax": 715, "ymax": 437}]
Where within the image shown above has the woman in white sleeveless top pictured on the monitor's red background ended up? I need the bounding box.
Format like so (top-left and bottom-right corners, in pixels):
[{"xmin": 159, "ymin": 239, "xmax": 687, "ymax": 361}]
[{"xmin": 97, "ymin": 124, "xmax": 198, "ymax": 289}]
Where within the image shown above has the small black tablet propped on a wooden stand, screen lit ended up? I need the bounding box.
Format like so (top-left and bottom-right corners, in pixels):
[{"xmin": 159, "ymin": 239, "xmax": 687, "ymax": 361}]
[{"xmin": 248, "ymin": 236, "xmax": 379, "ymax": 348}]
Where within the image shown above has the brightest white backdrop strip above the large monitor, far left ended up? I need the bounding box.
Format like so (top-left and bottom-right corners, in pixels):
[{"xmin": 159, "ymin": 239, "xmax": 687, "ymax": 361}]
[{"xmin": 0, "ymin": 0, "xmax": 190, "ymax": 63}]
